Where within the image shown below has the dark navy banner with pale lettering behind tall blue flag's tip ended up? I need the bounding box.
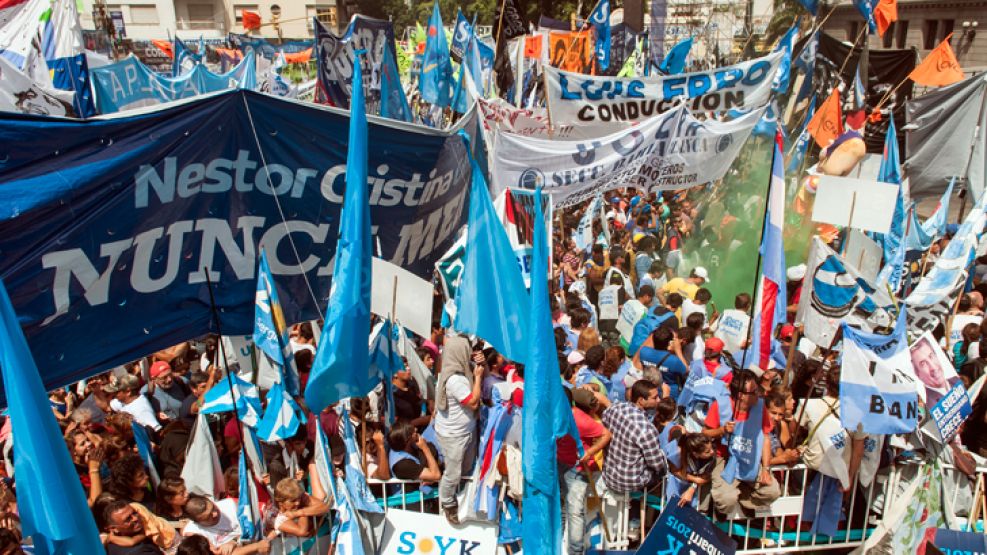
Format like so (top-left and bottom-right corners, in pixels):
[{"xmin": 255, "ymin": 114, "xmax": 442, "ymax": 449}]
[{"xmin": 313, "ymin": 15, "xmax": 398, "ymax": 114}]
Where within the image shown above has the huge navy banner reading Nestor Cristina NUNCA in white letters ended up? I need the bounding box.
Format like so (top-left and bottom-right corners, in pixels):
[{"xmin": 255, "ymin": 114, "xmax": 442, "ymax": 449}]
[{"xmin": 0, "ymin": 91, "xmax": 476, "ymax": 396}]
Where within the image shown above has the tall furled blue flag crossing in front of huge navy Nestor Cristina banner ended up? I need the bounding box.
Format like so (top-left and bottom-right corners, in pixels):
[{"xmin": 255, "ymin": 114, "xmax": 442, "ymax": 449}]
[{"xmin": 305, "ymin": 50, "xmax": 379, "ymax": 414}]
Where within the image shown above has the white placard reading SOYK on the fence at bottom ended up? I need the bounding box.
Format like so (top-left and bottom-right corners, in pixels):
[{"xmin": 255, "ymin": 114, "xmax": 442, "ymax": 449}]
[{"xmin": 380, "ymin": 509, "xmax": 497, "ymax": 555}]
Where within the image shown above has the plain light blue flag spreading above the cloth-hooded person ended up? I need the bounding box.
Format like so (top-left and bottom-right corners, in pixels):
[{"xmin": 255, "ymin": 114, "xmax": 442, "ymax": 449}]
[{"xmin": 452, "ymin": 131, "xmax": 531, "ymax": 362}]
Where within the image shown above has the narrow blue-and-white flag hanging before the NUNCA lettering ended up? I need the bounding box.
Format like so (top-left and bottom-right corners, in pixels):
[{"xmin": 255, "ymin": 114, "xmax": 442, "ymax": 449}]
[{"xmin": 253, "ymin": 249, "xmax": 299, "ymax": 395}]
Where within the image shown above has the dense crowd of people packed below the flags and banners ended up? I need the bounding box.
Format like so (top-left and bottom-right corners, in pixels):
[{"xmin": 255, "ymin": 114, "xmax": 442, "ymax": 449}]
[{"xmin": 0, "ymin": 184, "xmax": 987, "ymax": 555}]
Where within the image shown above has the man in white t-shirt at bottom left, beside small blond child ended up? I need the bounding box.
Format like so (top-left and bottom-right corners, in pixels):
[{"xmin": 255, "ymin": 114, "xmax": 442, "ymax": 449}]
[{"xmin": 182, "ymin": 495, "xmax": 270, "ymax": 555}]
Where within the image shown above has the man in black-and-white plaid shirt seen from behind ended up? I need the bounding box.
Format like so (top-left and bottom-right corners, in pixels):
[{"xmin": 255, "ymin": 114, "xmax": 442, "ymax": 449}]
[{"xmin": 603, "ymin": 380, "xmax": 668, "ymax": 493}]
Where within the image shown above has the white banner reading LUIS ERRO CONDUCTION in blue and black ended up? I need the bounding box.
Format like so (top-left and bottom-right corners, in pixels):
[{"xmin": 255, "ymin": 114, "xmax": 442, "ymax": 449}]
[{"xmin": 544, "ymin": 49, "xmax": 782, "ymax": 126}]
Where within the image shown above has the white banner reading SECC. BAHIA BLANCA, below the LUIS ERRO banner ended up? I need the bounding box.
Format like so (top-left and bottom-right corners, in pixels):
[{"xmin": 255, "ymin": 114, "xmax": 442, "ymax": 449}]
[{"xmin": 491, "ymin": 106, "xmax": 763, "ymax": 206}]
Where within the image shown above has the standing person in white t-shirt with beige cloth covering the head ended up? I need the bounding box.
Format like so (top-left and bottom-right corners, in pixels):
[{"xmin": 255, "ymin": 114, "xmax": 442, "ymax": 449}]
[{"xmin": 435, "ymin": 335, "xmax": 486, "ymax": 524}]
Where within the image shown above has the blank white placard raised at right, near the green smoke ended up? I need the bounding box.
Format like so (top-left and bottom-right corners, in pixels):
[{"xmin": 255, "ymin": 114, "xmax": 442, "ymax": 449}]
[{"xmin": 812, "ymin": 175, "xmax": 898, "ymax": 233}]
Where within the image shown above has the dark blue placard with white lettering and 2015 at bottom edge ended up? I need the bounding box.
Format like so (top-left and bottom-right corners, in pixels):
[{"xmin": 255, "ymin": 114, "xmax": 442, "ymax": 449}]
[{"xmin": 637, "ymin": 497, "xmax": 737, "ymax": 555}]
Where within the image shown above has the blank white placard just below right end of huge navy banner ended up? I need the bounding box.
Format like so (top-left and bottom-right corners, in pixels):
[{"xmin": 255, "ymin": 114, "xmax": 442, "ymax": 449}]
[{"xmin": 370, "ymin": 257, "xmax": 433, "ymax": 337}]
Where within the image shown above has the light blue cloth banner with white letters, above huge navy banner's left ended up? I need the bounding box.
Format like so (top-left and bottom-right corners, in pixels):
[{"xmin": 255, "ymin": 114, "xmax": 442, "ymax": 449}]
[{"xmin": 90, "ymin": 54, "xmax": 257, "ymax": 114}]
